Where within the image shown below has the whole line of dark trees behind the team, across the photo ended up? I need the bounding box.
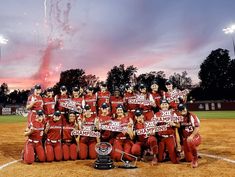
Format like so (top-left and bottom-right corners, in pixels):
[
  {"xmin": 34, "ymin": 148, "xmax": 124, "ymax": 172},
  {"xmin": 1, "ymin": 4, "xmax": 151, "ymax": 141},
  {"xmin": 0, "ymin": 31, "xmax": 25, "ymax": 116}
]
[{"xmin": 0, "ymin": 48, "xmax": 235, "ymax": 105}]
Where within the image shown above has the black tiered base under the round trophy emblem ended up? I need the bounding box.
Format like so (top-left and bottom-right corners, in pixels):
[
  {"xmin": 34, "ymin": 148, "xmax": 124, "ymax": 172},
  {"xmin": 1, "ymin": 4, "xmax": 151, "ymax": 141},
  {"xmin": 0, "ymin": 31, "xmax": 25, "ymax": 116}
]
[{"xmin": 94, "ymin": 155, "xmax": 114, "ymax": 170}]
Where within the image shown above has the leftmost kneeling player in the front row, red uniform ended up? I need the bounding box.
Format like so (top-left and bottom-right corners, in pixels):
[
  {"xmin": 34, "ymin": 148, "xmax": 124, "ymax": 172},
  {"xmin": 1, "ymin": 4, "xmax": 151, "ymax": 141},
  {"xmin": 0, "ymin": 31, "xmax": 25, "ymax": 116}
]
[{"xmin": 23, "ymin": 110, "xmax": 45, "ymax": 164}]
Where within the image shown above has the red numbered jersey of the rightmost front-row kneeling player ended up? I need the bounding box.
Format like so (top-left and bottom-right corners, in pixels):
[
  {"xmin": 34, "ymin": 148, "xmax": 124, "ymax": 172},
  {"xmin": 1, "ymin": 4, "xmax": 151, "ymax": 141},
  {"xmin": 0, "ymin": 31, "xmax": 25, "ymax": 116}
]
[{"xmin": 180, "ymin": 112, "xmax": 200, "ymax": 138}]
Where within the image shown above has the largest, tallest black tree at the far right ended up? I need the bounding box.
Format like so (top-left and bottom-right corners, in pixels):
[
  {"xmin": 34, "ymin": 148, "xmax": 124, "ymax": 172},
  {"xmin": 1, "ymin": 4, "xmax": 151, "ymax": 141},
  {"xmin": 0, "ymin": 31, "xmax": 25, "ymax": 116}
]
[{"xmin": 199, "ymin": 48, "xmax": 231, "ymax": 100}]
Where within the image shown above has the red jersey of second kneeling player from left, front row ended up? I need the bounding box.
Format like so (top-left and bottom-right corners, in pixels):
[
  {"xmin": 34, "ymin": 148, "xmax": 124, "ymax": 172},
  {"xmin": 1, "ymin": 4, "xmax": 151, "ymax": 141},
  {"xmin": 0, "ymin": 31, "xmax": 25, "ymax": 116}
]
[{"xmin": 47, "ymin": 119, "xmax": 62, "ymax": 140}]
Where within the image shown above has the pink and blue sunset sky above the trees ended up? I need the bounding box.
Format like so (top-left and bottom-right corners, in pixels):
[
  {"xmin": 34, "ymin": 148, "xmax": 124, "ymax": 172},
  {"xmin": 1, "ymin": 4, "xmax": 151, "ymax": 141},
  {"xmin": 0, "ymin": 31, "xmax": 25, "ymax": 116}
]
[{"xmin": 0, "ymin": 0, "xmax": 235, "ymax": 89}]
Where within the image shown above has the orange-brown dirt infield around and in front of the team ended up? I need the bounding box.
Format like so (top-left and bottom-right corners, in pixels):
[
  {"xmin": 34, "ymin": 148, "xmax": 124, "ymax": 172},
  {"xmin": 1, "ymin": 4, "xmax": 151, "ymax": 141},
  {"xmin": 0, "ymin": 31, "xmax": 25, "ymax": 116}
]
[{"xmin": 0, "ymin": 119, "xmax": 235, "ymax": 177}]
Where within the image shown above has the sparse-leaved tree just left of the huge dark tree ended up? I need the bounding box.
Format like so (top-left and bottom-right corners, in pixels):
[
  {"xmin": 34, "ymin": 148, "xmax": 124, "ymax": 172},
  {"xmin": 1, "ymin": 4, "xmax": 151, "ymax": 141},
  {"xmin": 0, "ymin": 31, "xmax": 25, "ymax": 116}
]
[{"xmin": 169, "ymin": 71, "xmax": 192, "ymax": 90}]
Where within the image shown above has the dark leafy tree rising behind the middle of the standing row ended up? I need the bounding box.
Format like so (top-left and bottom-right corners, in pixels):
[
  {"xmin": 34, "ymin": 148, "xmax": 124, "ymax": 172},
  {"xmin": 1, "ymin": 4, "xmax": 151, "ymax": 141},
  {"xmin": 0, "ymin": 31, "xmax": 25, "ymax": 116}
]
[{"xmin": 106, "ymin": 64, "xmax": 137, "ymax": 92}]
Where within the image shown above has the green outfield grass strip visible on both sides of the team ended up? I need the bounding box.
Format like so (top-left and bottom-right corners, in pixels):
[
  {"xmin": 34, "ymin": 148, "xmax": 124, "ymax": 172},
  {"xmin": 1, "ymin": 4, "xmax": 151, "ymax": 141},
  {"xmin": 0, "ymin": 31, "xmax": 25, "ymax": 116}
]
[{"xmin": 0, "ymin": 111, "xmax": 235, "ymax": 123}]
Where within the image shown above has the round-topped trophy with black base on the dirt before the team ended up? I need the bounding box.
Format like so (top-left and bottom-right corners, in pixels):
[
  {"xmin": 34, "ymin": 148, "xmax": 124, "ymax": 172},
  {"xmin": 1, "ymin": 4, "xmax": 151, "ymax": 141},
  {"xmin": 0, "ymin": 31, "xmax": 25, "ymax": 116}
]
[{"xmin": 94, "ymin": 142, "xmax": 114, "ymax": 170}]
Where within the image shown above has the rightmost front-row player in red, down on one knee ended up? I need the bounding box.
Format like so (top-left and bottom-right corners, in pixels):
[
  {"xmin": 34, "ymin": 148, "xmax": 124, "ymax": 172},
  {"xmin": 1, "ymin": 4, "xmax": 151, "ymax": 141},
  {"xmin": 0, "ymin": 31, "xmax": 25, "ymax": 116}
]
[{"xmin": 178, "ymin": 104, "xmax": 201, "ymax": 168}]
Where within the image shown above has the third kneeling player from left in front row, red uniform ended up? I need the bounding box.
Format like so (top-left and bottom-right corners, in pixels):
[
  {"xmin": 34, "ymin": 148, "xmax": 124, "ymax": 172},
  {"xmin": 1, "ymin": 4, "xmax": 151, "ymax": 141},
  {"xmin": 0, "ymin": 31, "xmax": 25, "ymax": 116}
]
[{"xmin": 62, "ymin": 112, "xmax": 78, "ymax": 160}]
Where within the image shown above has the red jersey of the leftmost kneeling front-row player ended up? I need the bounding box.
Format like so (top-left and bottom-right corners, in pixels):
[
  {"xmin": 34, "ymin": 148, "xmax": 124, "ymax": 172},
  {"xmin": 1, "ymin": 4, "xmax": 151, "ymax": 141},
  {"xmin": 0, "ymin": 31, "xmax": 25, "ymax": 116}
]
[{"xmin": 29, "ymin": 121, "xmax": 44, "ymax": 141}]
